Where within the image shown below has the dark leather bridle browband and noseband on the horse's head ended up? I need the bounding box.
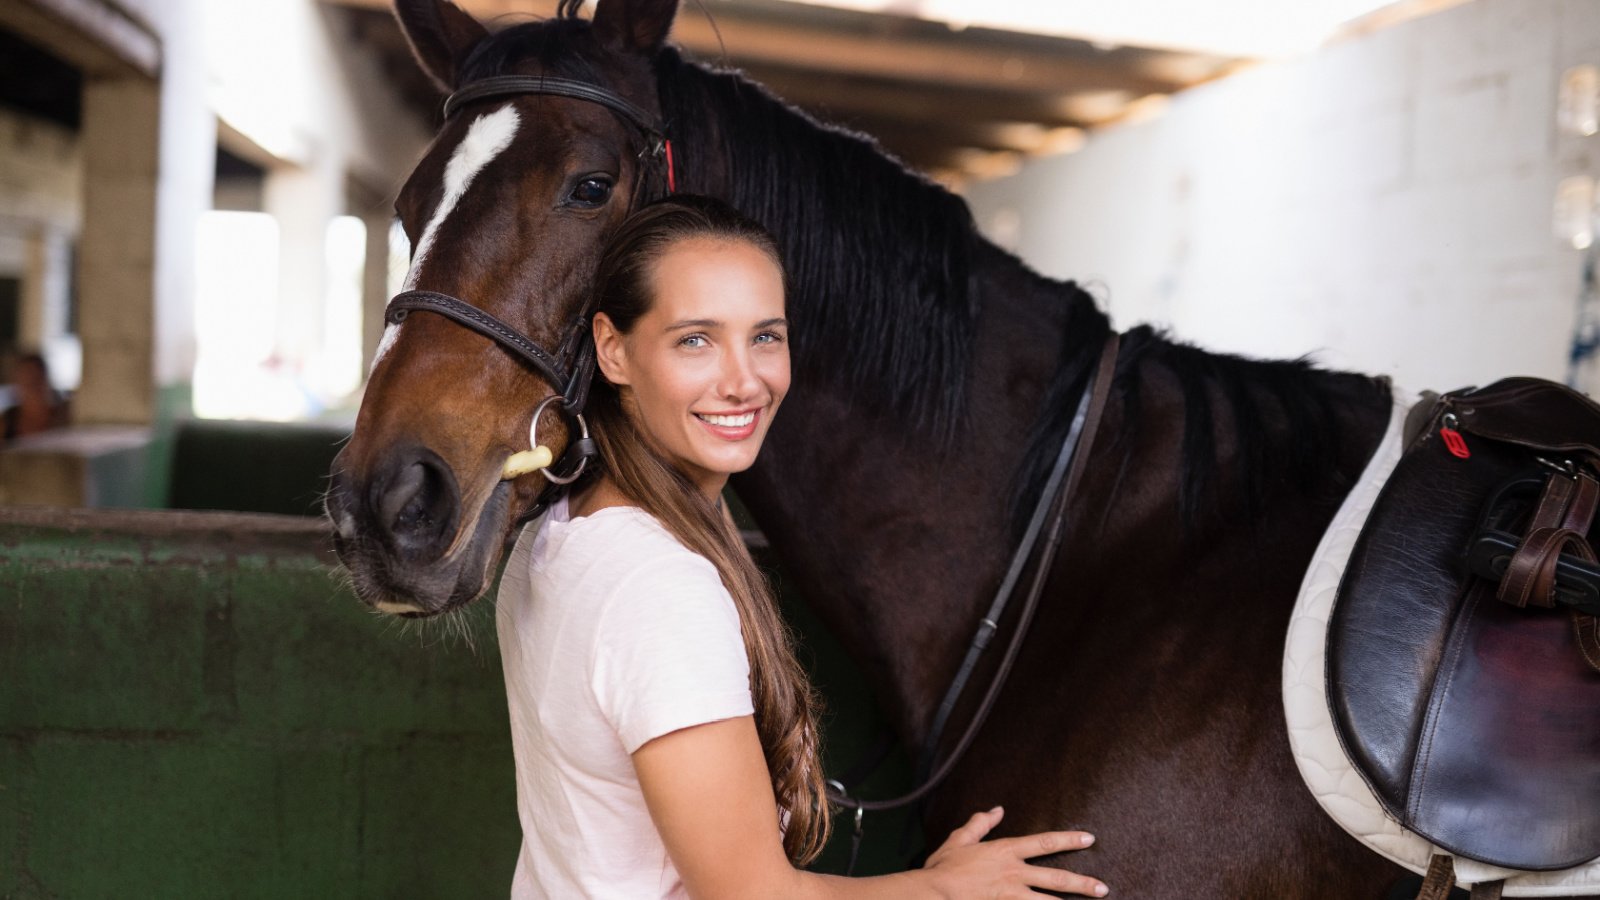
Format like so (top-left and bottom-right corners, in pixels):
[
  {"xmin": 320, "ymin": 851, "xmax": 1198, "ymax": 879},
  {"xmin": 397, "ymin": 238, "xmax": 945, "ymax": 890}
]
[{"xmin": 384, "ymin": 75, "xmax": 677, "ymax": 520}]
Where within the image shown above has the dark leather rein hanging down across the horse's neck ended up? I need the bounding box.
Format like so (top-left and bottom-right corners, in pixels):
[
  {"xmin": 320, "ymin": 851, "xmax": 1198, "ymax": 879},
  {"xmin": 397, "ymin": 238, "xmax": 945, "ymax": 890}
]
[{"xmin": 827, "ymin": 331, "xmax": 1122, "ymax": 871}]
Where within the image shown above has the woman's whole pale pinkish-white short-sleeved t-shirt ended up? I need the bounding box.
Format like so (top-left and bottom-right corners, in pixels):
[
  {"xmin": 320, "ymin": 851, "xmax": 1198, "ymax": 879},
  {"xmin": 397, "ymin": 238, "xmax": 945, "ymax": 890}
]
[{"xmin": 496, "ymin": 500, "xmax": 754, "ymax": 900}]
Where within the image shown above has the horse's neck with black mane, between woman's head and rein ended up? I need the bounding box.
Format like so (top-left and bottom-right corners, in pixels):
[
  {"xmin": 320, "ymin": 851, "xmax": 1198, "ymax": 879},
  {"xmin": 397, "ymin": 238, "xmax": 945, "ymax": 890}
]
[{"xmin": 658, "ymin": 51, "xmax": 1107, "ymax": 740}]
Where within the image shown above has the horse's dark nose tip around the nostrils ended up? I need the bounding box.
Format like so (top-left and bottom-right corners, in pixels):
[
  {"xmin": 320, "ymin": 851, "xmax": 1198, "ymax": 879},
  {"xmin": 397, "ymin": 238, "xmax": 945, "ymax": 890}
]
[{"xmin": 328, "ymin": 447, "xmax": 461, "ymax": 564}]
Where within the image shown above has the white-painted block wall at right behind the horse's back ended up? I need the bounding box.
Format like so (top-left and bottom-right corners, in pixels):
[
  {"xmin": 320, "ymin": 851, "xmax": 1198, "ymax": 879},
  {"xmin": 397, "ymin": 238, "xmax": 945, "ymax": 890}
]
[{"xmin": 970, "ymin": 0, "xmax": 1600, "ymax": 389}]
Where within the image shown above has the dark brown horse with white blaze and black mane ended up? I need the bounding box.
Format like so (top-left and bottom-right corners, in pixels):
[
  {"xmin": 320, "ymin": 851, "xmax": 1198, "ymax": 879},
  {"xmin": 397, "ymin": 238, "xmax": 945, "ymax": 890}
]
[{"xmin": 328, "ymin": 0, "xmax": 1440, "ymax": 898}]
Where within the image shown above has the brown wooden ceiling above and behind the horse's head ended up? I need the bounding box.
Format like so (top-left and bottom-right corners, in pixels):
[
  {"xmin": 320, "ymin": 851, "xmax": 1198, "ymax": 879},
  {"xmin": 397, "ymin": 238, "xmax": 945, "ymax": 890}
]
[{"xmin": 323, "ymin": 0, "xmax": 1243, "ymax": 184}]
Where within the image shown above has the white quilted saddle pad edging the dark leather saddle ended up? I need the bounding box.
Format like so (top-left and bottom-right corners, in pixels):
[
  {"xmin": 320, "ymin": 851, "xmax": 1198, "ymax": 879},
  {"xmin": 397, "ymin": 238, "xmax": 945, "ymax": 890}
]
[{"xmin": 1283, "ymin": 391, "xmax": 1600, "ymax": 897}]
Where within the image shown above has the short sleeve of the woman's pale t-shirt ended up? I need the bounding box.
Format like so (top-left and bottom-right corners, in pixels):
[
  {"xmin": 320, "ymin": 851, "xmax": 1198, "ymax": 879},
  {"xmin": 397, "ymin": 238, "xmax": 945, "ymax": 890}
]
[{"xmin": 590, "ymin": 554, "xmax": 754, "ymax": 754}]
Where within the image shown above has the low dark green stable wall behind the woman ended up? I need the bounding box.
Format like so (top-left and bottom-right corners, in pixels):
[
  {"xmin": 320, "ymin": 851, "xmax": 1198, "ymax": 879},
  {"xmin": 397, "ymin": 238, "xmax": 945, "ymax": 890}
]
[{"xmin": 0, "ymin": 509, "xmax": 907, "ymax": 898}]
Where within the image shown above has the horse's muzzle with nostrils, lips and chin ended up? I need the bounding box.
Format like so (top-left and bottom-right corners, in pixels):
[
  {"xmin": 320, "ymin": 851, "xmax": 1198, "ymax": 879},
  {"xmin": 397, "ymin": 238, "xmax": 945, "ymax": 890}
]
[{"xmin": 326, "ymin": 447, "xmax": 512, "ymax": 617}]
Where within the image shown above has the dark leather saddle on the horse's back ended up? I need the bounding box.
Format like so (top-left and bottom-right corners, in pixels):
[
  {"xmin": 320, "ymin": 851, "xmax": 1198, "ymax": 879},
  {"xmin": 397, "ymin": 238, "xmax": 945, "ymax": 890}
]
[{"xmin": 1326, "ymin": 378, "xmax": 1600, "ymax": 871}]
